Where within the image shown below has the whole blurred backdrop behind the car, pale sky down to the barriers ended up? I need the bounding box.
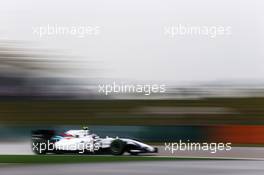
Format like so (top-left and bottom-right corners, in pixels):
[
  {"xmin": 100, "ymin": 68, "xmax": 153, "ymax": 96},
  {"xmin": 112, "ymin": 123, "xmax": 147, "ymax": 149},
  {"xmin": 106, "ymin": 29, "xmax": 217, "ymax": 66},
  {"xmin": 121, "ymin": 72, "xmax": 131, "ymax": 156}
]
[{"xmin": 0, "ymin": 0, "xmax": 264, "ymax": 146}]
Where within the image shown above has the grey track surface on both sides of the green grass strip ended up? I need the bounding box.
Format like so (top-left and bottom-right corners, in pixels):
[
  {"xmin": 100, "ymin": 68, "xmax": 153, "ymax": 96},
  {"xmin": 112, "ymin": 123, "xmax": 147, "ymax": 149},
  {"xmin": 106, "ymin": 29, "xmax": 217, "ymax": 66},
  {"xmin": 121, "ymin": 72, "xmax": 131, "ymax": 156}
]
[{"xmin": 0, "ymin": 142, "xmax": 264, "ymax": 175}]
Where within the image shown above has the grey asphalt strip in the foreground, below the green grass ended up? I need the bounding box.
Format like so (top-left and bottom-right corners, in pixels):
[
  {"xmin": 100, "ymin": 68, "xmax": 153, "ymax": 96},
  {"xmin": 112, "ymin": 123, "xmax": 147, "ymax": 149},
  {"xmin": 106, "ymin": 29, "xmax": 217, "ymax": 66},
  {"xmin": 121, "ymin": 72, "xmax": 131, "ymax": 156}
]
[{"xmin": 0, "ymin": 160, "xmax": 264, "ymax": 175}]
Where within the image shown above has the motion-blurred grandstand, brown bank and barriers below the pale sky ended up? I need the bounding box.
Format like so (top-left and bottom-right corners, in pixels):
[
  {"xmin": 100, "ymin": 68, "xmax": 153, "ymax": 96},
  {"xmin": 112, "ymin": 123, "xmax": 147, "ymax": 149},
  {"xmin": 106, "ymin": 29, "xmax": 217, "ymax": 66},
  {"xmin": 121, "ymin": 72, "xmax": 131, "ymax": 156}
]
[{"xmin": 0, "ymin": 42, "xmax": 264, "ymax": 148}]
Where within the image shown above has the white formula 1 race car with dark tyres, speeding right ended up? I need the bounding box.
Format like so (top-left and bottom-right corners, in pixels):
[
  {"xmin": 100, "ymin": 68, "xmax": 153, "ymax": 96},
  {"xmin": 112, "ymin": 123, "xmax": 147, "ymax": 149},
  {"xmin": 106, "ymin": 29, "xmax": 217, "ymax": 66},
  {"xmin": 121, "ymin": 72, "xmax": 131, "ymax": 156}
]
[{"xmin": 32, "ymin": 127, "xmax": 158, "ymax": 155}]
